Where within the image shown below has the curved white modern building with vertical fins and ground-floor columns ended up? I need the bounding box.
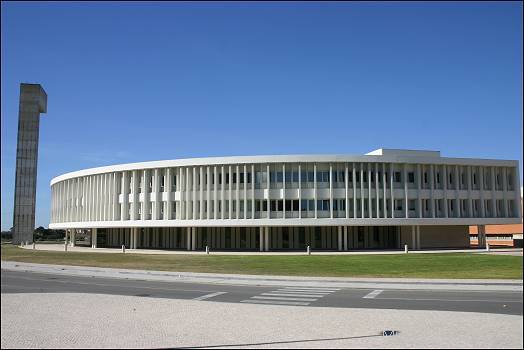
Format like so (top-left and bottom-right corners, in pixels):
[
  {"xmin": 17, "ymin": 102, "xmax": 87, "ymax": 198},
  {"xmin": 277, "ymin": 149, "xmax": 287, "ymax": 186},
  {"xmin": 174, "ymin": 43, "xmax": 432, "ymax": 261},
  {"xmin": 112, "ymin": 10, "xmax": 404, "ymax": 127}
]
[{"xmin": 49, "ymin": 149, "xmax": 521, "ymax": 251}]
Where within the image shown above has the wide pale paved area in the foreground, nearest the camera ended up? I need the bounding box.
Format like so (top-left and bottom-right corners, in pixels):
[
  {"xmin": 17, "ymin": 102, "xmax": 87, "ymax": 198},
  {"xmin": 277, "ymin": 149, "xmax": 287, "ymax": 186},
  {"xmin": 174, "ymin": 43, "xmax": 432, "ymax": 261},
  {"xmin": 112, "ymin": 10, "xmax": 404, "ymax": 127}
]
[{"xmin": 1, "ymin": 293, "xmax": 523, "ymax": 349}]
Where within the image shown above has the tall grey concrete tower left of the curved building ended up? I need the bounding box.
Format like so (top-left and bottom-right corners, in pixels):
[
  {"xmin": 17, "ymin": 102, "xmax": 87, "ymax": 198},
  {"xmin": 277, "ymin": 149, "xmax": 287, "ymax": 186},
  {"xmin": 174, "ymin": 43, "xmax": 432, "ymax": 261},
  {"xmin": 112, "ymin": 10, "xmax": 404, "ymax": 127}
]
[{"xmin": 13, "ymin": 83, "xmax": 47, "ymax": 244}]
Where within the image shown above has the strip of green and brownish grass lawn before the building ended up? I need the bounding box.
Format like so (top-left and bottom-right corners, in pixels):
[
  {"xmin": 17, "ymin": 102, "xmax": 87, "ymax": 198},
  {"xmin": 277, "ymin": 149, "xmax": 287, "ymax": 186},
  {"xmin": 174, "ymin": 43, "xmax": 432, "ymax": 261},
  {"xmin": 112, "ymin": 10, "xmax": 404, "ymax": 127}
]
[{"xmin": 1, "ymin": 244, "xmax": 522, "ymax": 279}]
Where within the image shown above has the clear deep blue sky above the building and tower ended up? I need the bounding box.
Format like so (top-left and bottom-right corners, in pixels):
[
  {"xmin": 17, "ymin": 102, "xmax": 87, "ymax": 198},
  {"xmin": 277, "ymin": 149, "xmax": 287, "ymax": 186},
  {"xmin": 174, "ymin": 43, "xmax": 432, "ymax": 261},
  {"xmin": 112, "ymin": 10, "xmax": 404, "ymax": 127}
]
[{"xmin": 1, "ymin": 2, "xmax": 523, "ymax": 230}]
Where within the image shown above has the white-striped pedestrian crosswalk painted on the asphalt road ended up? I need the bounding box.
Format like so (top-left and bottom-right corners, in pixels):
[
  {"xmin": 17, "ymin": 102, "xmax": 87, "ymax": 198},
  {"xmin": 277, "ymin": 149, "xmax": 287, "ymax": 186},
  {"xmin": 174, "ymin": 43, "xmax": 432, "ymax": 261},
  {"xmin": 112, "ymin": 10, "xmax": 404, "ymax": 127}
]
[{"xmin": 241, "ymin": 287, "xmax": 340, "ymax": 306}]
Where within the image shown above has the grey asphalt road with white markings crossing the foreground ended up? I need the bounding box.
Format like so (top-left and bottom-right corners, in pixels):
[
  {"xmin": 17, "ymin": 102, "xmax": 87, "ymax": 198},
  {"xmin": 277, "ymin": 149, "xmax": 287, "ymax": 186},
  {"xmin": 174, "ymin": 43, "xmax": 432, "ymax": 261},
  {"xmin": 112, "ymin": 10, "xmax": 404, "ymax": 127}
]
[{"xmin": 1, "ymin": 270, "xmax": 523, "ymax": 315}]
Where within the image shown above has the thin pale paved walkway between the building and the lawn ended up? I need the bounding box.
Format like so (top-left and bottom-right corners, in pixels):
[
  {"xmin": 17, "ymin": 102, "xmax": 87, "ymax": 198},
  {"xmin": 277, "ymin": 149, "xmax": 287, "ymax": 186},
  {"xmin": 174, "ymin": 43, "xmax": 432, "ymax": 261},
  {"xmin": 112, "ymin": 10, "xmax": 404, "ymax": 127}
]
[{"xmin": 18, "ymin": 244, "xmax": 522, "ymax": 256}]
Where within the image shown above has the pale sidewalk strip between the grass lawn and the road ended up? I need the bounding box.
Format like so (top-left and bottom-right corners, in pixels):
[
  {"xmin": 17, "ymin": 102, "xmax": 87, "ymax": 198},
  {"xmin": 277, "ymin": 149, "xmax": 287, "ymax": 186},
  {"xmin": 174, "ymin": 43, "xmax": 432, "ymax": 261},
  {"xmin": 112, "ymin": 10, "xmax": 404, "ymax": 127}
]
[{"xmin": 1, "ymin": 261, "xmax": 523, "ymax": 292}]
